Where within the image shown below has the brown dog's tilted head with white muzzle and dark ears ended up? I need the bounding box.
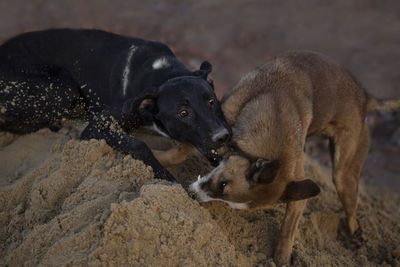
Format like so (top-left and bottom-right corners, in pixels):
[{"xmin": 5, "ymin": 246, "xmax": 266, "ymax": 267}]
[{"xmin": 190, "ymin": 155, "xmax": 320, "ymax": 209}]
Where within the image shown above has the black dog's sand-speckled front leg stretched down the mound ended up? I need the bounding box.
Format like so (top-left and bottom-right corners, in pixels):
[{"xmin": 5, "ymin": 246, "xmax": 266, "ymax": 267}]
[{"xmin": 81, "ymin": 112, "xmax": 177, "ymax": 183}]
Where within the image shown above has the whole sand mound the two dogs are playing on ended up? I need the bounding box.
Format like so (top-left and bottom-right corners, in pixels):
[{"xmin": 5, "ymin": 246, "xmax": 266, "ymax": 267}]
[{"xmin": 0, "ymin": 124, "xmax": 400, "ymax": 266}]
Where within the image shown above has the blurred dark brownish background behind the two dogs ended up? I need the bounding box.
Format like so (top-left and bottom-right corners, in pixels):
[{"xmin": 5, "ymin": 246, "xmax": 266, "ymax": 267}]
[{"xmin": 0, "ymin": 0, "xmax": 400, "ymax": 192}]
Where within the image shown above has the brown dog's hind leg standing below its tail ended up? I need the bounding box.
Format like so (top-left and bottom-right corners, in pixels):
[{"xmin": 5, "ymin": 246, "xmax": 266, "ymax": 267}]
[{"xmin": 333, "ymin": 125, "xmax": 369, "ymax": 235}]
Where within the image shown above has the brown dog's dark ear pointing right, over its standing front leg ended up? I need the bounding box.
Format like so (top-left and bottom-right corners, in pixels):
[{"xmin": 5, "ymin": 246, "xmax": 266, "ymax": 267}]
[{"xmin": 282, "ymin": 179, "xmax": 321, "ymax": 202}]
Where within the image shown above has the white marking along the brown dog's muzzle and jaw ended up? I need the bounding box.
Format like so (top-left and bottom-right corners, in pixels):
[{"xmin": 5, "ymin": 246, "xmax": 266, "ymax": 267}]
[{"xmin": 190, "ymin": 161, "xmax": 249, "ymax": 210}]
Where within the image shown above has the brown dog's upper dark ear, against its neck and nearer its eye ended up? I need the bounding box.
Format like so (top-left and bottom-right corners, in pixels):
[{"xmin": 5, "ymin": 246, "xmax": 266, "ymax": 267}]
[{"xmin": 247, "ymin": 159, "xmax": 280, "ymax": 184}]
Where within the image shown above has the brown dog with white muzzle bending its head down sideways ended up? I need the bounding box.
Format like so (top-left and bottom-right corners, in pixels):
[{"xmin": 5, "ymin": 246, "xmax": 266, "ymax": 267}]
[{"xmin": 191, "ymin": 52, "xmax": 400, "ymax": 264}]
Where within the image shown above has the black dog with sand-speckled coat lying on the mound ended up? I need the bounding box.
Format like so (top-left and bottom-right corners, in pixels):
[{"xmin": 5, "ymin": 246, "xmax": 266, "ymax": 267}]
[{"xmin": 0, "ymin": 29, "xmax": 231, "ymax": 184}]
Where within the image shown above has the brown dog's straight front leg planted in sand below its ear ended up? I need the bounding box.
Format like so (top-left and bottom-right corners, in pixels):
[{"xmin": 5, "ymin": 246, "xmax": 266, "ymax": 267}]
[{"xmin": 274, "ymin": 200, "xmax": 307, "ymax": 266}]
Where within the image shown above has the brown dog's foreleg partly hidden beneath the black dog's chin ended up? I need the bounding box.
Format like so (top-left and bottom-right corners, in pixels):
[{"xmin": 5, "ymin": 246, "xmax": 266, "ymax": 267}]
[{"xmin": 152, "ymin": 143, "xmax": 194, "ymax": 168}]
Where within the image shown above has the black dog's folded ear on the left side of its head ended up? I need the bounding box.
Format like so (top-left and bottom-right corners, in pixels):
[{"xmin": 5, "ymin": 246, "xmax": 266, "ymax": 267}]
[{"xmin": 122, "ymin": 87, "xmax": 158, "ymax": 114}]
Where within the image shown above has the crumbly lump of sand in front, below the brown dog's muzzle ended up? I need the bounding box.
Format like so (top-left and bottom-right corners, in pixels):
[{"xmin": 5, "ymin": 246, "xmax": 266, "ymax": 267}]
[{"xmin": 93, "ymin": 185, "xmax": 244, "ymax": 266}]
